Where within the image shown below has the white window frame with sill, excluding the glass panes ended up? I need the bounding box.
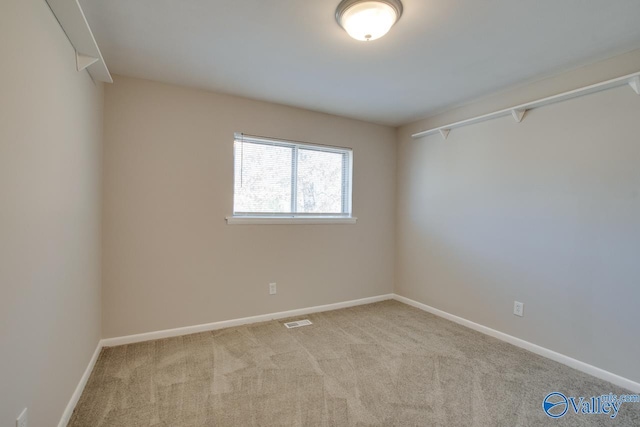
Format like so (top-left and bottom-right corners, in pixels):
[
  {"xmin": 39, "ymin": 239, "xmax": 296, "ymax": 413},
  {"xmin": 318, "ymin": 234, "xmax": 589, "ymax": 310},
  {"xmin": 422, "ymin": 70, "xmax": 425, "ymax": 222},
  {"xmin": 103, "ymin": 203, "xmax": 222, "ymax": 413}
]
[{"xmin": 226, "ymin": 133, "xmax": 357, "ymax": 225}]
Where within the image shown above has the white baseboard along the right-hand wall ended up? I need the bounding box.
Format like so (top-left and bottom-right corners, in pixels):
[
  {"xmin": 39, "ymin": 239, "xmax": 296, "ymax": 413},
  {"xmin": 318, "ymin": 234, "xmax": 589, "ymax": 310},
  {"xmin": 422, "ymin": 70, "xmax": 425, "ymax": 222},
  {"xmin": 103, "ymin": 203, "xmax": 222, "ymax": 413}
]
[{"xmin": 394, "ymin": 294, "xmax": 640, "ymax": 393}]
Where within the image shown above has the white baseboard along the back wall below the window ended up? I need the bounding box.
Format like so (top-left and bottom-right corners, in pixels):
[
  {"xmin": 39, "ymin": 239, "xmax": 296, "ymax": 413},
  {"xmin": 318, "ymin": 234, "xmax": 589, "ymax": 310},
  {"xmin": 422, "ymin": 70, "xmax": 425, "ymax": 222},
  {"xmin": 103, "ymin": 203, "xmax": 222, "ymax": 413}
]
[{"xmin": 101, "ymin": 294, "xmax": 394, "ymax": 347}]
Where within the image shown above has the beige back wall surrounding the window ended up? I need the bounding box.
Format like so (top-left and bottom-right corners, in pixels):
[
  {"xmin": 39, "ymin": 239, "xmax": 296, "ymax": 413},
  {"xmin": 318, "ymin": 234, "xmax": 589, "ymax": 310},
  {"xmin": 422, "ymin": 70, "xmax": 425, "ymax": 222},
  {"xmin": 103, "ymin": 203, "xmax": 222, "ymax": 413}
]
[{"xmin": 103, "ymin": 77, "xmax": 396, "ymax": 338}]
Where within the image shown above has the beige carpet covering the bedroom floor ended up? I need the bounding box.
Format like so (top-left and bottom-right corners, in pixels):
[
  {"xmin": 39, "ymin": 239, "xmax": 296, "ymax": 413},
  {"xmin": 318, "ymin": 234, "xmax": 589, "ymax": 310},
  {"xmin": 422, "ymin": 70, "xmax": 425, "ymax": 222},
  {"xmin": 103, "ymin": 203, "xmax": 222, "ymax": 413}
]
[{"xmin": 69, "ymin": 301, "xmax": 640, "ymax": 427}]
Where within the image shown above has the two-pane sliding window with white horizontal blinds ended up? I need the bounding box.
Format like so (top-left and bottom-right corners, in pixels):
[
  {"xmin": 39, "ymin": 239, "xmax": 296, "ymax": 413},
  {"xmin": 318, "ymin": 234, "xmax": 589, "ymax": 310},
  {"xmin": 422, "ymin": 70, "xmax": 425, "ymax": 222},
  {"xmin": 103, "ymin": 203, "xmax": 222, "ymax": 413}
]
[{"xmin": 232, "ymin": 134, "xmax": 352, "ymax": 224}]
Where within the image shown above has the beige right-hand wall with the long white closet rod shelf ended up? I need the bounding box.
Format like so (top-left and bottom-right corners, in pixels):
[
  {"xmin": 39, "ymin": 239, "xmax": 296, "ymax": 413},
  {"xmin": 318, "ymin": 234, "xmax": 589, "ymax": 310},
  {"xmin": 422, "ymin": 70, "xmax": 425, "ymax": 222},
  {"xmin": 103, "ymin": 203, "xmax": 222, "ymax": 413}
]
[{"xmin": 395, "ymin": 51, "xmax": 640, "ymax": 381}]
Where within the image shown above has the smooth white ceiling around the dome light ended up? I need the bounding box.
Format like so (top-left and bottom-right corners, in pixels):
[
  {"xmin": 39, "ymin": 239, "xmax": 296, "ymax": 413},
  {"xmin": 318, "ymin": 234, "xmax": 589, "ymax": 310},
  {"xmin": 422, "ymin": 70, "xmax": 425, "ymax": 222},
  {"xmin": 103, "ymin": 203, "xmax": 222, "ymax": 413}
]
[{"xmin": 81, "ymin": 0, "xmax": 640, "ymax": 126}]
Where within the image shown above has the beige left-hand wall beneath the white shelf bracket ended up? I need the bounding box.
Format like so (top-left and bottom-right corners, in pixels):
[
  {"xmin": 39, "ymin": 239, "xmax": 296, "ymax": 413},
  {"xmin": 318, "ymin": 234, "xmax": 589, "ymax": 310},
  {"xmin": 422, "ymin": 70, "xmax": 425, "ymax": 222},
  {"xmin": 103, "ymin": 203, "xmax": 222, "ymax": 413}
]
[{"xmin": 0, "ymin": 0, "xmax": 102, "ymax": 427}]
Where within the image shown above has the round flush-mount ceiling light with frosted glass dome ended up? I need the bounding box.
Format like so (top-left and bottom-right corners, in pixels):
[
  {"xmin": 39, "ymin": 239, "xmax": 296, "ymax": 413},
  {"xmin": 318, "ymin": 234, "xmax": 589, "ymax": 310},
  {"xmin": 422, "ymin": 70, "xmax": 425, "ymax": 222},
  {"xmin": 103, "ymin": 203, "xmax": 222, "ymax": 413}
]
[{"xmin": 336, "ymin": 0, "xmax": 402, "ymax": 41}]
